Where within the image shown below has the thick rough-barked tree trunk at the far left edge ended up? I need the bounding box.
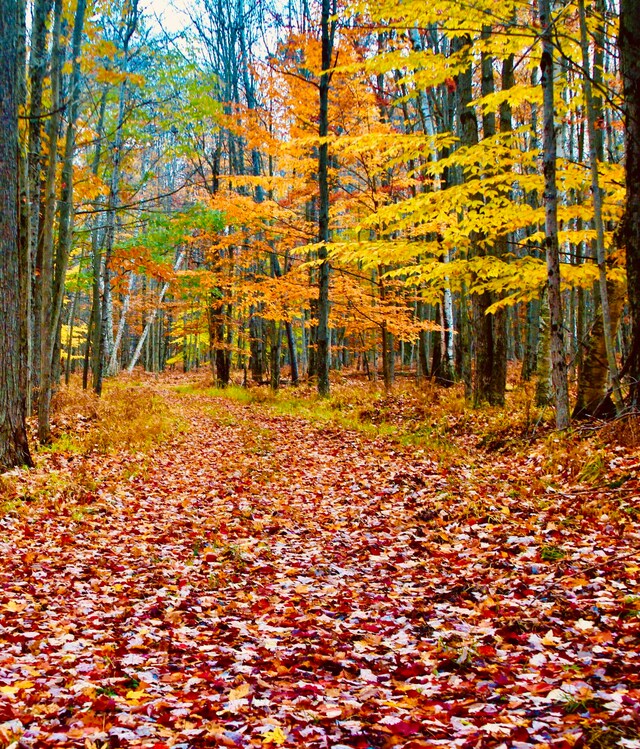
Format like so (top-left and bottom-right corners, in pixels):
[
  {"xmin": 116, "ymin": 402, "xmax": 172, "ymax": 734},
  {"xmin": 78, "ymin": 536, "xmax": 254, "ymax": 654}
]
[{"xmin": 0, "ymin": 0, "xmax": 33, "ymax": 469}]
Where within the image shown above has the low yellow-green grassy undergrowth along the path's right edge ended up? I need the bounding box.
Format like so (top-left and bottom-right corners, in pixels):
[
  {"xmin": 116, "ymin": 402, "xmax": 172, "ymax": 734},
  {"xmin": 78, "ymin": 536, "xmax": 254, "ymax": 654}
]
[{"xmin": 174, "ymin": 376, "xmax": 640, "ymax": 487}]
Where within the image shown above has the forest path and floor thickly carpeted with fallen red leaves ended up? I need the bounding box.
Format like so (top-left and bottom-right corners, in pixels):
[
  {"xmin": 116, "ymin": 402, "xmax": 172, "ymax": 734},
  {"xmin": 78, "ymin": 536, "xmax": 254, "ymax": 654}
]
[{"xmin": 0, "ymin": 381, "xmax": 640, "ymax": 749}]
